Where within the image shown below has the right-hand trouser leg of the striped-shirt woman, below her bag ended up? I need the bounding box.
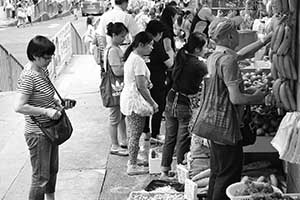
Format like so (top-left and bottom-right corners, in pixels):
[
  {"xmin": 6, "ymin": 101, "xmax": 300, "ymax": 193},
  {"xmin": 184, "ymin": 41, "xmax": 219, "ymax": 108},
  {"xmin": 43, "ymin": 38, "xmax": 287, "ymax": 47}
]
[{"xmin": 45, "ymin": 145, "xmax": 59, "ymax": 200}]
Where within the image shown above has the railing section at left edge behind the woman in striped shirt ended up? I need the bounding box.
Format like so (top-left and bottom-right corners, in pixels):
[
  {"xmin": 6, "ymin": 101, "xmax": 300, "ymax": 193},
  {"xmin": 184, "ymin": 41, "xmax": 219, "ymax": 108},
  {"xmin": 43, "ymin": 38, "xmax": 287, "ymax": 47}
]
[{"xmin": 0, "ymin": 45, "xmax": 24, "ymax": 92}]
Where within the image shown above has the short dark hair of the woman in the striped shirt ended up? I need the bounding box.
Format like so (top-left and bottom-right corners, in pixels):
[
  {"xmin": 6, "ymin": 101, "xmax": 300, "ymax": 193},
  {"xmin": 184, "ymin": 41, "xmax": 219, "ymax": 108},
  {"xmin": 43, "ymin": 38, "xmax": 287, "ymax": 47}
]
[{"xmin": 27, "ymin": 35, "xmax": 55, "ymax": 61}]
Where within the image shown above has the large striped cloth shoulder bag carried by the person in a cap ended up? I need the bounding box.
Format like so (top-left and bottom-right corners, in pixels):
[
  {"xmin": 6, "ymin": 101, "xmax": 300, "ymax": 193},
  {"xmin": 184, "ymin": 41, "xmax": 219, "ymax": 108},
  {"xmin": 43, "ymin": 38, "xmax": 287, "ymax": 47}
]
[{"xmin": 192, "ymin": 54, "xmax": 242, "ymax": 145}]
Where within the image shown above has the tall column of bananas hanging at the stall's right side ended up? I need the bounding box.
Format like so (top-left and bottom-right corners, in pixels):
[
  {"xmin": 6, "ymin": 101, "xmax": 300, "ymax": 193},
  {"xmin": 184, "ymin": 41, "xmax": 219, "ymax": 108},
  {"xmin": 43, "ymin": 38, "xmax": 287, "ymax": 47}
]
[{"xmin": 269, "ymin": 0, "xmax": 298, "ymax": 111}]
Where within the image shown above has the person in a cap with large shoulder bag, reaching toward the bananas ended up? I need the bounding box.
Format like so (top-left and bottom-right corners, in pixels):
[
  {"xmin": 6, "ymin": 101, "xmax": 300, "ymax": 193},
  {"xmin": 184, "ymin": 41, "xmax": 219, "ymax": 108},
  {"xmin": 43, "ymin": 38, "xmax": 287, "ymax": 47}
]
[{"xmin": 192, "ymin": 18, "xmax": 271, "ymax": 200}]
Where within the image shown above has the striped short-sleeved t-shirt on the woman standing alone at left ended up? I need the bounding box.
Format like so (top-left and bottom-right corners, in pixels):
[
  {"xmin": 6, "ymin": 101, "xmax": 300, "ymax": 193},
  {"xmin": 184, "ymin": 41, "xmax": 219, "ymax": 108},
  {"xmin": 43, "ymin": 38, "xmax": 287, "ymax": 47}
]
[{"xmin": 17, "ymin": 69, "xmax": 55, "ymax": 134}]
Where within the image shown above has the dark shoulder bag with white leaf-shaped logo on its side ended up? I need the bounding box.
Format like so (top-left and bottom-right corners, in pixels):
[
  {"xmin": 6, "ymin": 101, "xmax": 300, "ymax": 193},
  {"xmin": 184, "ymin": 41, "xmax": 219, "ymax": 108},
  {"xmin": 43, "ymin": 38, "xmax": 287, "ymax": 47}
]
[{"xmin": 100, "ymin": 48, "xmax": 124, "ymax": 107}]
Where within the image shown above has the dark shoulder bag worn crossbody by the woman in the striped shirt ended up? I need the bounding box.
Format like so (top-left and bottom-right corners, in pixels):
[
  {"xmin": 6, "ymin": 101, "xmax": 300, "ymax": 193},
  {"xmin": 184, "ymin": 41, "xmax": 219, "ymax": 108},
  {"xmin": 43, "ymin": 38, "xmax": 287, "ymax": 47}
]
[{"xmin": 30, "ymin": 77, "xmax": 73, "ymax": 145}]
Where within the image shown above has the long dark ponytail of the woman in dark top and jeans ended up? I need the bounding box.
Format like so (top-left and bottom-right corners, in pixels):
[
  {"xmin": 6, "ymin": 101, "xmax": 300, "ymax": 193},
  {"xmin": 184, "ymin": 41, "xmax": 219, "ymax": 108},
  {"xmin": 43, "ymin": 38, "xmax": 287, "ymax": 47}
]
[{"xmin": 172, "ymin": 32, "xmax": 207, "ymax": 82}]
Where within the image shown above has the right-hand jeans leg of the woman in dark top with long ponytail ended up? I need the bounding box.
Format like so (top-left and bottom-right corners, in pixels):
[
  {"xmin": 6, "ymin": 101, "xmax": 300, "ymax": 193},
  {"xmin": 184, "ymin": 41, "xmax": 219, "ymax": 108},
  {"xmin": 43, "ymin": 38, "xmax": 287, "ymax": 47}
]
[{"xmin": 176, "ymin": 104, "xmax": 192, "ymax": 164}]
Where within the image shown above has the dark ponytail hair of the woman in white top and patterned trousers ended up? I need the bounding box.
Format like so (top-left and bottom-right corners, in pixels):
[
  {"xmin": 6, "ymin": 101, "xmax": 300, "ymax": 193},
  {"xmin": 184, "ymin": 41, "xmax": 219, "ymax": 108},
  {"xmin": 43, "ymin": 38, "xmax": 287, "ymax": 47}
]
[{"xmin": 124, "ymin": 31, "xmax": 153, "ymax": 61}]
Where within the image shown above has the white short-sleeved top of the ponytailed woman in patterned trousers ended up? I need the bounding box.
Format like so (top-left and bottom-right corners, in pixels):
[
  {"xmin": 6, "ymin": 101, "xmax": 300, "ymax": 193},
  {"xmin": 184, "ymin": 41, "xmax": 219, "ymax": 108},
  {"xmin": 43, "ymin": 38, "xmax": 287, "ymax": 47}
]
[{"xmin": 120, "ymin": 52, "xmax": 150, "ymax": 115}]
